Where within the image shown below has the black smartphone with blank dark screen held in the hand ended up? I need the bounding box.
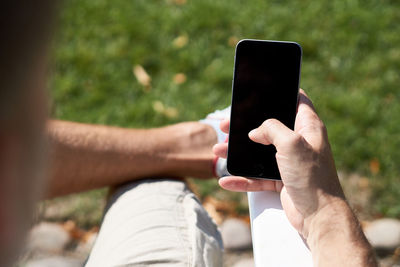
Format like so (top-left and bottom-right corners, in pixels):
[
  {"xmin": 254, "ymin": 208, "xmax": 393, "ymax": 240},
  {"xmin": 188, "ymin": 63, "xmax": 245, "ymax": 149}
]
[{"xmin": 227, "ymin": 39, "xmax": 302, "ymax": 180}]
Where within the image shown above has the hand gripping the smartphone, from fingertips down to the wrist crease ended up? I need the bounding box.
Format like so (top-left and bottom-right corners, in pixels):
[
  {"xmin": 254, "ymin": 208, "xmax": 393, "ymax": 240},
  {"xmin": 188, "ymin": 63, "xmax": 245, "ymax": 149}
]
[{"xmin": 214, "ymin": 90, "xmax": 344, "ymax": 238}]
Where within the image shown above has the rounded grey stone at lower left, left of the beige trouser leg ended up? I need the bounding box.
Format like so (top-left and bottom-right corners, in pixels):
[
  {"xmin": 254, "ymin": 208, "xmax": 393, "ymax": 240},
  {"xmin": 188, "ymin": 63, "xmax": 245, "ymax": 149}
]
[{"xmin": 27, "ymin": 222, "xmax": 71, "ymax": 252}]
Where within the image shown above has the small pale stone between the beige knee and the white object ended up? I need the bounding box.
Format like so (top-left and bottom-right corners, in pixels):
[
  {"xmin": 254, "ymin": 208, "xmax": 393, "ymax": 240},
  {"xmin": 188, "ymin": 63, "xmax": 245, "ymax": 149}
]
[{"xmin": 221, "ymin": 219, "xmax": 252, "ymax": 250}]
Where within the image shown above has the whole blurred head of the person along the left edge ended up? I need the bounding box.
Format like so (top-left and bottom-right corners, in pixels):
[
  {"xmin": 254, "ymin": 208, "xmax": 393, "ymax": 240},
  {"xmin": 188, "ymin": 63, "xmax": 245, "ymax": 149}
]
[{"xmin": 0, "ymin": 0, "xmax": 54, "ymax": 266}]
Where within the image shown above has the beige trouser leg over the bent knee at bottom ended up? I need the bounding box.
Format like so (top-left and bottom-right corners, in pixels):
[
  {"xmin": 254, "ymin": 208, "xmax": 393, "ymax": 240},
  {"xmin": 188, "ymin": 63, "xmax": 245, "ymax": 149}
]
[{"xmin": 86, "ymin": 179, "xmax": 222, "ymax": 267}]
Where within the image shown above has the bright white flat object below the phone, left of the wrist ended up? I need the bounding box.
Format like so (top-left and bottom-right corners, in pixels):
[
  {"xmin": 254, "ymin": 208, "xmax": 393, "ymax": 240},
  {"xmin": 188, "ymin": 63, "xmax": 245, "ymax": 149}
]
[{"xmin": 247, "ymin": 191, "xmax": 313, "ymax": 267}]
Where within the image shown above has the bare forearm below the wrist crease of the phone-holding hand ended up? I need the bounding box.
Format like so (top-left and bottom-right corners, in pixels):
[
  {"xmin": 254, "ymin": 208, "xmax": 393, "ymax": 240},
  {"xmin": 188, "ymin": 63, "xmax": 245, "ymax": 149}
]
[{"xmin": 307, "ymin": 200, "xmax": 378, "ymax": 267}]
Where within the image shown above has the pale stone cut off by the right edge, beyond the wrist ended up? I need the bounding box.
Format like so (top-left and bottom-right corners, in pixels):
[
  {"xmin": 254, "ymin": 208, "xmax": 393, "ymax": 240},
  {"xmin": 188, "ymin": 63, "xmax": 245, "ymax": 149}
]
[{"xmin": 364, "ymin": 218, "xmax": 400, "ymax": 251}]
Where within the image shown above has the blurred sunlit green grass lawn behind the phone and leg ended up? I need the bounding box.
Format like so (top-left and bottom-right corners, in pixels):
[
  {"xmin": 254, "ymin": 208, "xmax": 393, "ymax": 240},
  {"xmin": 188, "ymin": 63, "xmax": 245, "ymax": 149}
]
[{"xmin": 50, "ymin": 0, "xmax": 400, "ymax": 223}]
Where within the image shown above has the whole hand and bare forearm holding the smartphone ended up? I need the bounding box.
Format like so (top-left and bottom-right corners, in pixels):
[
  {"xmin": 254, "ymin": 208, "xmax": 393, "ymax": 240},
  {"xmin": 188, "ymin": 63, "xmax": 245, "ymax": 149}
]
[{"xmin": 213, "ymin": 90, "xmax": 376, "ymax": 266}]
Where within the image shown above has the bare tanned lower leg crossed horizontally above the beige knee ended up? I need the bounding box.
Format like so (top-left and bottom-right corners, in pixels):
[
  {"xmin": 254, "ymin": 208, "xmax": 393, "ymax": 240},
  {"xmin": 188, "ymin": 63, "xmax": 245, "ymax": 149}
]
[{"xmin": 46, "ymin": 120, "xmax": 216, "ymax": 197}]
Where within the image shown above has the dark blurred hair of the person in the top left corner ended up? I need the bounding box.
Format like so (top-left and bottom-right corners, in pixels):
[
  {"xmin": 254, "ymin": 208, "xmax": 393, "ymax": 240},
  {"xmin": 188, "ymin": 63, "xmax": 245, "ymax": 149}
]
[{"xmin": 0, "ymin": 0, "xmax": 56, "ymax": 119}]
